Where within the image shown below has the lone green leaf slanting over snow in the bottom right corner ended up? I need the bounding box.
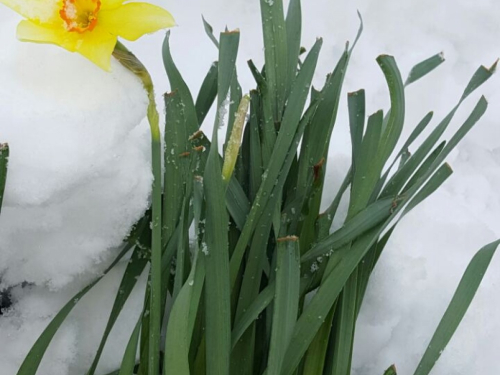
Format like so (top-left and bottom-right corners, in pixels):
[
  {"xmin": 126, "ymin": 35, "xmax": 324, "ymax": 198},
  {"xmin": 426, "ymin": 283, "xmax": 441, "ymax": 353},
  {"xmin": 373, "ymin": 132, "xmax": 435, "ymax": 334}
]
[{"xmin": 414, "ymin": 240, "xmax": 500, "ymax": 375}]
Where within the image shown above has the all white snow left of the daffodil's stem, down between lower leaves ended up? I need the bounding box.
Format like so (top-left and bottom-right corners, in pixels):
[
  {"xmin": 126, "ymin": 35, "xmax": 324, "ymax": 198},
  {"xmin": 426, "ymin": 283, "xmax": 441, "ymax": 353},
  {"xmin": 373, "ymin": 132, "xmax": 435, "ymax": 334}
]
[{"xmin": 0, "ymin": 11, "xmax": 152, "ymax": 375}]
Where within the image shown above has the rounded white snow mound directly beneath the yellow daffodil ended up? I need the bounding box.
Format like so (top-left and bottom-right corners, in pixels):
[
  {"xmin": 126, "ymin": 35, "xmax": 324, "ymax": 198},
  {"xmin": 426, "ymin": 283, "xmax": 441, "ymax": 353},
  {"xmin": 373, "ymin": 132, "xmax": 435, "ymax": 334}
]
[{"xmin": 0, "ymin": 13, "xmax": 152, "ymax": 289}]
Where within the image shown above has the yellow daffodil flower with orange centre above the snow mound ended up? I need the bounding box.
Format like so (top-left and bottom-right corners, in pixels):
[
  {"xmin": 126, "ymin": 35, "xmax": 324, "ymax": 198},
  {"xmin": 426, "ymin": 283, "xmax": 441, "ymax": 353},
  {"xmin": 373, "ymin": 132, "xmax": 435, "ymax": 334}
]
[{"xmin": 0, "ymin": 0, "xmax": 175, "ymax": 71}]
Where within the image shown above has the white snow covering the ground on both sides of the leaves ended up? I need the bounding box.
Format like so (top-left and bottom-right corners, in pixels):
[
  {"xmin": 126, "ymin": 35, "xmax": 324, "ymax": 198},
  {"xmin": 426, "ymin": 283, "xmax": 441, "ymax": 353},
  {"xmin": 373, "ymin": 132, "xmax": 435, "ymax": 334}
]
[{"xmin": 0, "ymin": 0, "xmax": 500, "ymax": 375}]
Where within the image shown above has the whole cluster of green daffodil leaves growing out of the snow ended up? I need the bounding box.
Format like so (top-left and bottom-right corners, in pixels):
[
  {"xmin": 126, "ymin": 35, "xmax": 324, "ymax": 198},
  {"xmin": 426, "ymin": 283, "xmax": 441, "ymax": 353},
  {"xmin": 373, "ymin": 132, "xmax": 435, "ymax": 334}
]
[{"xmin": 13, "ymin": 0, "xmax": 499, "ymax": 375}]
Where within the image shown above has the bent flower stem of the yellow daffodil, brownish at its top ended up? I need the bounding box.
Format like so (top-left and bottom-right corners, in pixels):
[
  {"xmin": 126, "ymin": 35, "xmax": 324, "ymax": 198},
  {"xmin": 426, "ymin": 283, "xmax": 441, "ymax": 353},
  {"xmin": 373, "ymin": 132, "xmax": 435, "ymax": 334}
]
[{"xmin": 113, "ymin": 42, "xmax": 162, "ymax": 375}]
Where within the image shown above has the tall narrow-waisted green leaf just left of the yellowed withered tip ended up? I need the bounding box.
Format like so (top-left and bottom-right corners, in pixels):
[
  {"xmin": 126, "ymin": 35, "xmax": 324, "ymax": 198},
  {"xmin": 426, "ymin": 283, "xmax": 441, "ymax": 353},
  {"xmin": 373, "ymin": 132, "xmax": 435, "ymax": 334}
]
[{"xmin": 204, "ymin": 32, "xmax": 239, "ymax": 375}]
